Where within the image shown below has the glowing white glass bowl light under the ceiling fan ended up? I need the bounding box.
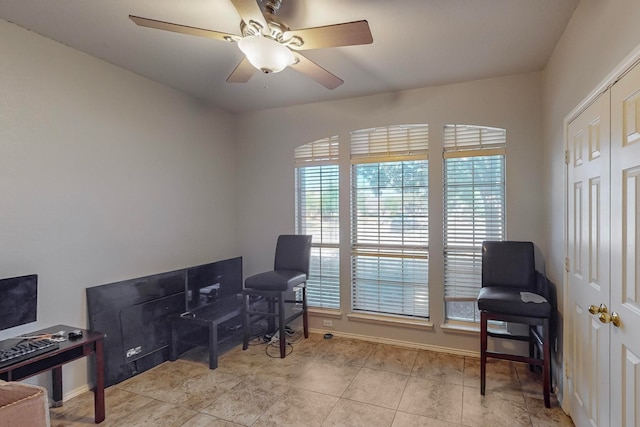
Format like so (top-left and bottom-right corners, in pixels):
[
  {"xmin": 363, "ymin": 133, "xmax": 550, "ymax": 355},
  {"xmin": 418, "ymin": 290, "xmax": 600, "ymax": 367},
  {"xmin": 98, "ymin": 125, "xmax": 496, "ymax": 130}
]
[{"xmin": 238, "ymin": 36, "xmax": 296, "ymax": 73}]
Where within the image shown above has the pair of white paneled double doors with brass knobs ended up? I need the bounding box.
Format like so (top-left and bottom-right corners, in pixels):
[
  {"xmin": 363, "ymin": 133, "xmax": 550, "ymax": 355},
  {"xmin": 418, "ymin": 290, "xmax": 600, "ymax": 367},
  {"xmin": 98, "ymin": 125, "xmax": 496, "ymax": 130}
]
[{"xmin": 565, "ymin": 61, "xmax": 640, "ymax": 427}]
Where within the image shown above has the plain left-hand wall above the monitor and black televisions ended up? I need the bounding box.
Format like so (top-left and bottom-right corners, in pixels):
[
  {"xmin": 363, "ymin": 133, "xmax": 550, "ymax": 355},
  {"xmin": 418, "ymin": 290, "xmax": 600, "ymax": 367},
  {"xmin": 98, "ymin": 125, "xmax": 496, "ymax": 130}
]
[{"xmin": 0, "ymin": 20, "xmax": 239, "ymax": 393}]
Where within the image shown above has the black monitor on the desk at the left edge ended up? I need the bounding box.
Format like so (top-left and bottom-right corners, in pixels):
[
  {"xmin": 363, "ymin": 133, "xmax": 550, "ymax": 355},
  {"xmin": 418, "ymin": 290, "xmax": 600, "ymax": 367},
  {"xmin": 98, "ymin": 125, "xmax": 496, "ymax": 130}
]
[{"xmin": 0, "ymin": 274, "xmax": 38, "ymax": 330}]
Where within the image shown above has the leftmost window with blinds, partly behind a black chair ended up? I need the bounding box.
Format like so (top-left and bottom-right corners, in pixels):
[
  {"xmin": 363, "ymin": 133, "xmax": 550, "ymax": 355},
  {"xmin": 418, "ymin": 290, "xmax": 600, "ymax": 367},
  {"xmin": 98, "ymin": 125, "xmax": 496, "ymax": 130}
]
[{"xmin": 295, "ymin": 136, "xmax": 340, "ymax": 309}]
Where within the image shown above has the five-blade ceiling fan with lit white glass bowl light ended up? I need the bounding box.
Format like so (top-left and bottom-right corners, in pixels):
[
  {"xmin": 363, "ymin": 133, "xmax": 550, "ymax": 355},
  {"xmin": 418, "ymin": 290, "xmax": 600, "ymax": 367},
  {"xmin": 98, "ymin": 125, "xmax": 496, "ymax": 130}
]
[{"xmin": 129, "ymin": 0, "xmax": 373, "ymax": 89}]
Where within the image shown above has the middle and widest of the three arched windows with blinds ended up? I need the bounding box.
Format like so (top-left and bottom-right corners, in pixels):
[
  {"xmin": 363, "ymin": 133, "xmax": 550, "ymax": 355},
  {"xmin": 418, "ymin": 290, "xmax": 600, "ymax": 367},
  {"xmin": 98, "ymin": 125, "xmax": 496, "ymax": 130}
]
[{"xmin": 350, "ymin": 125, "xmax": 429, "ymax": 319}]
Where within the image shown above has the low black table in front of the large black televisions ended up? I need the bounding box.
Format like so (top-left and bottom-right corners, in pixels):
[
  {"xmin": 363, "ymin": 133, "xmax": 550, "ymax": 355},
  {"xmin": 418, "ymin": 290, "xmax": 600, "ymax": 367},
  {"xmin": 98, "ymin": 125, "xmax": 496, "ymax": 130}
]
[{"xmin": 169, "ymin": 295, "xmax": 242, "ymax": 369}]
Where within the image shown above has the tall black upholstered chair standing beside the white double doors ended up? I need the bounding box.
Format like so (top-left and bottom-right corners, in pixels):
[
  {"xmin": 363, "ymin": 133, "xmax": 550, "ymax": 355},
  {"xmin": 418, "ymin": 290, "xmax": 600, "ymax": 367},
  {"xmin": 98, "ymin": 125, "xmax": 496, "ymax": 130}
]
[{"xmin": 478, "ymin": 241, "xmax": 554, "ymax": 408}]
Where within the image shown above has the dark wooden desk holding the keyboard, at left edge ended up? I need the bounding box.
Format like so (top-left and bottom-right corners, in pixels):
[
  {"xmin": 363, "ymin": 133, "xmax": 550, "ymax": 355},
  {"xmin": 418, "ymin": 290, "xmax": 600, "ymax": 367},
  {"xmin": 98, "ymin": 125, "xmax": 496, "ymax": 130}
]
[{"xmin": 0, "ymin": 325, "xmax": 105, "ymax": 424}]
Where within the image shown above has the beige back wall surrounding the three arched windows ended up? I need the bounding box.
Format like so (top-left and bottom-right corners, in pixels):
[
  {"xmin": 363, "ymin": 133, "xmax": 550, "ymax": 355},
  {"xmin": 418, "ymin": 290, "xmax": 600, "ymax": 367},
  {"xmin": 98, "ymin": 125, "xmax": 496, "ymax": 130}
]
[{"xmin": 236, "ymin": 73, "xmax": 544, "ymax": 352}]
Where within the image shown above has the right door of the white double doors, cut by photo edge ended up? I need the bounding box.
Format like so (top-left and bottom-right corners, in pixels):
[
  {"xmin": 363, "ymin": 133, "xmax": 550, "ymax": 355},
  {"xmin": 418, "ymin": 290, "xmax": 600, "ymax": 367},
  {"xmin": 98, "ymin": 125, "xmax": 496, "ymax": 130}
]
[{"xmin": 610, "ymin": 61, "xmax": 640, "ymax": 427}]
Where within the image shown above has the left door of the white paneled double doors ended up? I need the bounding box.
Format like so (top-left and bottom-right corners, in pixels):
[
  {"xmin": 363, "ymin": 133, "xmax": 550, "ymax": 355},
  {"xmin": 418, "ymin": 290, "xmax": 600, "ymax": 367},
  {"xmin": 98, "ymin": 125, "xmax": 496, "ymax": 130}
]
[{"xmin": 565, "ymin": 92, "xmax": 611, "ymax": 427}]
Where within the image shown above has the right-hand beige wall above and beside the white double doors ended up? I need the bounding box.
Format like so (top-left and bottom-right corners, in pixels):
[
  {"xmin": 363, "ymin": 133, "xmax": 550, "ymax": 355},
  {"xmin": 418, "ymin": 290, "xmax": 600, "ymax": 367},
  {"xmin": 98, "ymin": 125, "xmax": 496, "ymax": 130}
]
[{"xmin": 542, "ymin": 0, "xmax": 640, "ymax": 404}]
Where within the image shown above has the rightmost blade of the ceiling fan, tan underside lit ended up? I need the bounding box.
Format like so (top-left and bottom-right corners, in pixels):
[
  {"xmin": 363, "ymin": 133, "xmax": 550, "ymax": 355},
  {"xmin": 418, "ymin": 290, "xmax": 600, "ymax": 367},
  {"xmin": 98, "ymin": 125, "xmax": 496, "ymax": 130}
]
[{"xmin": 283, "ymin": 21, "xmax": 373, "ymax": 50}]
